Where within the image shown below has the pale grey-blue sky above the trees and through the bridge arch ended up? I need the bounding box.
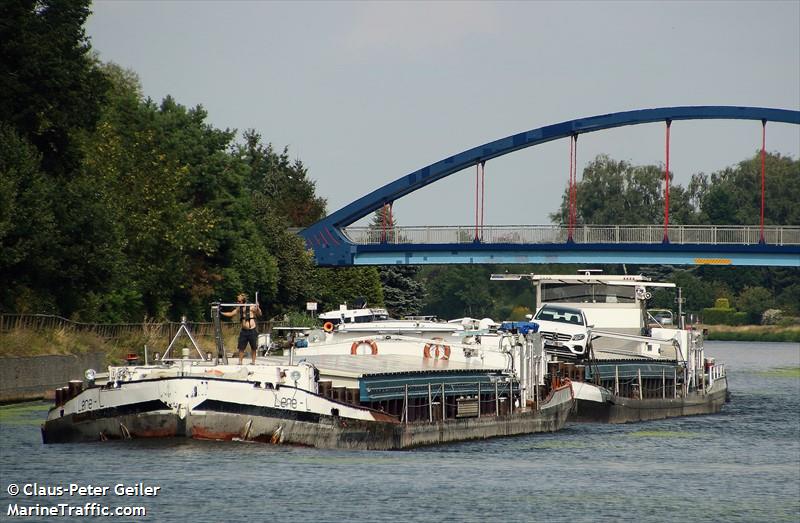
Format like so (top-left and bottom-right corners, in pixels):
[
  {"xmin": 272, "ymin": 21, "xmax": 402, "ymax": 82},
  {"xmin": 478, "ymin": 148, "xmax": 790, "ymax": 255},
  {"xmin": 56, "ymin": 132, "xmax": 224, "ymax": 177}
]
[{"xmin": 87, "ymin": 0, "xmax": 800, "ymax": 225}]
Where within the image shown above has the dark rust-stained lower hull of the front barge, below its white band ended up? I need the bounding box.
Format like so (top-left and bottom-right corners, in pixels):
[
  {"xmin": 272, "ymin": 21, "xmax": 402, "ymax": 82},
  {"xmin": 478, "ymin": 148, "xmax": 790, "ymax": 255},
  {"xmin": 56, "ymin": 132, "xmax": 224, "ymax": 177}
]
[{"xmin": 42, "ymin": 386, "xmax": 574, "ymax": 450}]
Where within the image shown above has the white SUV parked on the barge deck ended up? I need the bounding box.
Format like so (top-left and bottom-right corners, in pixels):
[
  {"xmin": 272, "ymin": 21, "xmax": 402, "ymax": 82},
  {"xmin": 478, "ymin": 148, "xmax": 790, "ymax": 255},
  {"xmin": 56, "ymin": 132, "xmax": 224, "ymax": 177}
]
[{"xmin": 533, "ymin": 303, "xmax": 592, "ymax": 359}]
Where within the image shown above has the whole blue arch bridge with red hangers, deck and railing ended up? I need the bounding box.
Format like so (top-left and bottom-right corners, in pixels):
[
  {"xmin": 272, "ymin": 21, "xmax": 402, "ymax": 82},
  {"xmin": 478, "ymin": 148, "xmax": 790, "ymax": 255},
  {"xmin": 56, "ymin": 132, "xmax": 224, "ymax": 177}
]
[{"xmin": 300, "ymin": 106, "xmax": 800, "ymax": 267}]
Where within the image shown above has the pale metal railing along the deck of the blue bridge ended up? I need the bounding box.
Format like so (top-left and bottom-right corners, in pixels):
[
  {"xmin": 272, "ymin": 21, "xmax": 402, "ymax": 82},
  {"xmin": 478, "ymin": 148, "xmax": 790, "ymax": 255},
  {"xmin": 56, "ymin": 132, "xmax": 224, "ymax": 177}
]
[{"xmin": 342, "ymin": 225, "xmax": 800, "ymax": 245}]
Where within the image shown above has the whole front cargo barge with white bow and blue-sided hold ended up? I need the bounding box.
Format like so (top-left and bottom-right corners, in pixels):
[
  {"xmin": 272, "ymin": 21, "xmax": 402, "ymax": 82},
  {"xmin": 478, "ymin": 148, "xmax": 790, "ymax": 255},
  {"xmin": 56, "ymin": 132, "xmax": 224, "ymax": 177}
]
[{"xmin": 42, "ymin": 305, "xmax": 574, "ymax": 450}]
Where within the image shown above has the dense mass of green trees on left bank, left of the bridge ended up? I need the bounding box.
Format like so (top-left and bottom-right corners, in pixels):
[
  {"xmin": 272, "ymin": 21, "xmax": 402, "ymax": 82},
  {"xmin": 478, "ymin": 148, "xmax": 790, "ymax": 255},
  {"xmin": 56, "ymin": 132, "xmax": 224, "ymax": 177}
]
[{"xmin": 0, "ymin": 0, "xmax": 383, "ymax": 321}]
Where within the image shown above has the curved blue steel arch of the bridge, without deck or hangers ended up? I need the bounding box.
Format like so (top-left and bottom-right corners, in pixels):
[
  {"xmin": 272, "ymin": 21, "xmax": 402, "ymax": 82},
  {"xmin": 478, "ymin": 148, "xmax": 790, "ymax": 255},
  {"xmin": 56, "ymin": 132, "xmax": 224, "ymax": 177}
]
[{"xmin": 301, "ymin": 106, "xmax": 800, "ymax": 265}]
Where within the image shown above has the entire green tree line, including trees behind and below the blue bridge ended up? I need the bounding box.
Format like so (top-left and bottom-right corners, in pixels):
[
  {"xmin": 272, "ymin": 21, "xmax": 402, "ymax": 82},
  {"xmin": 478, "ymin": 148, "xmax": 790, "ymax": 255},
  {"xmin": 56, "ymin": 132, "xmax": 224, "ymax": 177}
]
[{"xmin": 0, "ymin": 0, "xmax": 800, "ymax": 322}]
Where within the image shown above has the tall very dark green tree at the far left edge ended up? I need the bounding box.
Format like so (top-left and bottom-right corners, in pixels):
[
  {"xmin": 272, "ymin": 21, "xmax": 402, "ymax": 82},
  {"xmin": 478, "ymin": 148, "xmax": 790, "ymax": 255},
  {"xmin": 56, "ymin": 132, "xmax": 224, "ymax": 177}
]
[{"xmin": 0, "ymin": 0, "xmax": 108, "ymax": 314}]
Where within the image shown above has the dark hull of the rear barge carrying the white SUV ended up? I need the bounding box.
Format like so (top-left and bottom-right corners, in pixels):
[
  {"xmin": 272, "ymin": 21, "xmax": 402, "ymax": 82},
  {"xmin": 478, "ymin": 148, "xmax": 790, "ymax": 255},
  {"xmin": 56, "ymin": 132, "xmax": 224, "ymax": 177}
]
[{"xmin": 569, "ymin": 377, "xmax": 728, "ymax": 423}]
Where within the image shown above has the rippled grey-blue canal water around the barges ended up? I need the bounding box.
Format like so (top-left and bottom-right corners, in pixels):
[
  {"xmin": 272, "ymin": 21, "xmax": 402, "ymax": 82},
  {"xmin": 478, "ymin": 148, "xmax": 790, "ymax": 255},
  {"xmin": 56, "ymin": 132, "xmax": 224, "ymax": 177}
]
[{"xmin": 0, "ymin": 342, "xmax": 800, "ymax": 523}]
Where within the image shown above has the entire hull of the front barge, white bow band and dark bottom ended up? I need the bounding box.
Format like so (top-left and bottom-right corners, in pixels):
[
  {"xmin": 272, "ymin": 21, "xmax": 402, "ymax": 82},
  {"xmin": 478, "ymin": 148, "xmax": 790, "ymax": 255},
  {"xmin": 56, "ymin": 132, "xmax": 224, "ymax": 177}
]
[{"xmin": 42, "ymin": 376, "xmax": 574, "ymax": 450}]
